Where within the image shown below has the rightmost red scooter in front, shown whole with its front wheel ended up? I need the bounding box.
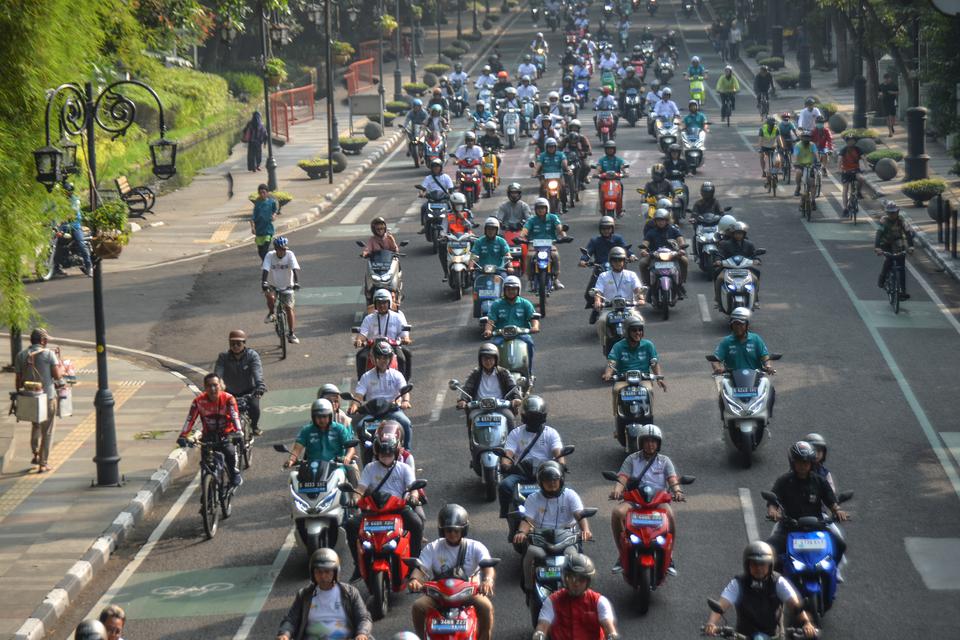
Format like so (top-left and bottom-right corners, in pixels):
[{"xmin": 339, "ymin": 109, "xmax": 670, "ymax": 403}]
[{"xmin": 603, "ymin": 471, "xmax": 696, "ymax": 615}]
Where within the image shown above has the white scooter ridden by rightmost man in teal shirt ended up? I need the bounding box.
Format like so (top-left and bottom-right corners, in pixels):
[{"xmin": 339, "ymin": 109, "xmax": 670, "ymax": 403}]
[{"xmin": 707, "ymin": 353, "xmax": 783, "ymax": 469}]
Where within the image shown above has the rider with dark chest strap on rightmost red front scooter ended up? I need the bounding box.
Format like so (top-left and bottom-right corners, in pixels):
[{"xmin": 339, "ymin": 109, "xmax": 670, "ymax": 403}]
[{"xmin": 610, "ymin": 424, "xmax": 686, "ymax": 575}]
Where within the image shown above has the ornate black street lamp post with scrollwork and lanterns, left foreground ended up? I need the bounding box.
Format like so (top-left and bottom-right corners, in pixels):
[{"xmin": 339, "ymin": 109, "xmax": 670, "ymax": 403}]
[{"xmin": 33, "ymin": 80, "xmax": 177, "ymax": 487}]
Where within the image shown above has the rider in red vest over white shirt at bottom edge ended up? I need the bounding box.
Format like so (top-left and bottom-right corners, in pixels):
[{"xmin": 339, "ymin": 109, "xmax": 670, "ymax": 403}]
[{"xmin": 532, "ymin": 553, "xmax": 620, "ymax": 640}]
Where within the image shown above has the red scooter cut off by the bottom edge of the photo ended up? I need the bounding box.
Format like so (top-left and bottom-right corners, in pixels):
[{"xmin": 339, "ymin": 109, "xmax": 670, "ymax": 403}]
[{"xmin": 404, "ymin": 558, "xmax": 500, "ymax": 640}]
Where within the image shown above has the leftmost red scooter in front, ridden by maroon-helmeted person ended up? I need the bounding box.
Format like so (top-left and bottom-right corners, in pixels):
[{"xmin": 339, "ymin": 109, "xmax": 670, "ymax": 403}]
[{"xmin": 340, "ymin": 480, "xmax": 427, "ymax": 620}]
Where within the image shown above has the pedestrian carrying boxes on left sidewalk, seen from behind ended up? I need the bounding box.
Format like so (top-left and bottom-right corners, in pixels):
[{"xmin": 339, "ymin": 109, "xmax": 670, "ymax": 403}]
[{"xmin": 14, "ymin": 329, "xmax": 63, "ymax": 473}]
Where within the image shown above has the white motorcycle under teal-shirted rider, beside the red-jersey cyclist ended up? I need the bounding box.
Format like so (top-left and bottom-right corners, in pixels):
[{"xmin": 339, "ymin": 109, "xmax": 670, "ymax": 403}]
[{"xmin": 273, "ymin": 440, "xmax": 359, "ymax": 558}]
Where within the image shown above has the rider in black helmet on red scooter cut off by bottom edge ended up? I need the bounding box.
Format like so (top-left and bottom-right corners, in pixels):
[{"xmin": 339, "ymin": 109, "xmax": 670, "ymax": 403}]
[{"xmin": 407, "ymin": 503, "xmax": 494, "ymax": 640}]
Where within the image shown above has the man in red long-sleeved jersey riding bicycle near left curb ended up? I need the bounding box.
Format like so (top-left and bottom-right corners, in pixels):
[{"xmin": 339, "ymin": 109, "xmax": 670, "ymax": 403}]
[{"xmin": 177, "ymin": 373, "xmax": 243, "ymax": 487}]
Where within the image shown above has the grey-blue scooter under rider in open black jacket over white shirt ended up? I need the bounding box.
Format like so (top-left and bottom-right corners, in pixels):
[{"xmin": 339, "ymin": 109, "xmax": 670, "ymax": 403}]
[{"xmin": 448, "ymin": 380, "xmax": 513, "ymax": 502}]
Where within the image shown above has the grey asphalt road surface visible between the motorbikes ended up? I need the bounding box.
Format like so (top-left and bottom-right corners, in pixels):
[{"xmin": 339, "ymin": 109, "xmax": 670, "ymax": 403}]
[{"xmin": 31, "ymin": 2, "xmax": 960, "ymax": 639}]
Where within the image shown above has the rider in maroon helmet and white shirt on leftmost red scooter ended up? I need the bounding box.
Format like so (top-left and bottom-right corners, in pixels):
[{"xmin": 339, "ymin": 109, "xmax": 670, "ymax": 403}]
[{"xmin": 343, "ymin": 432, "xmax": 423, "ymax": 582}]
